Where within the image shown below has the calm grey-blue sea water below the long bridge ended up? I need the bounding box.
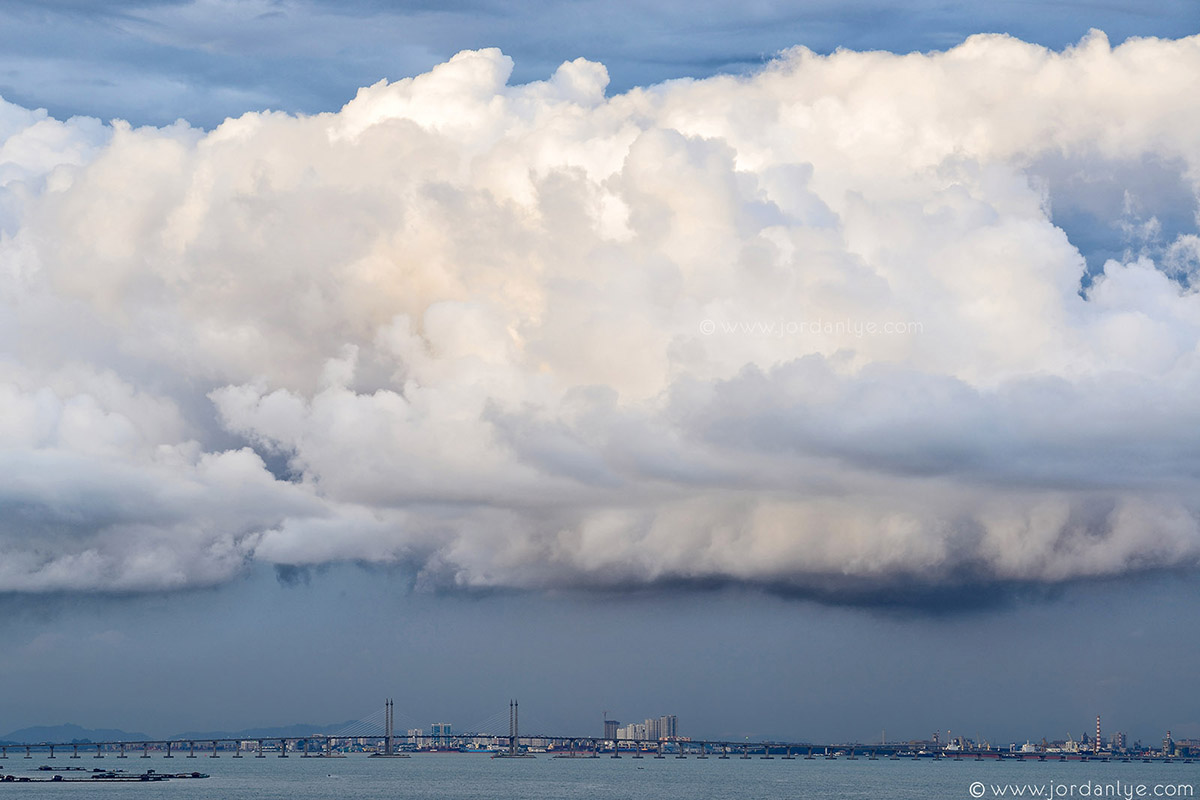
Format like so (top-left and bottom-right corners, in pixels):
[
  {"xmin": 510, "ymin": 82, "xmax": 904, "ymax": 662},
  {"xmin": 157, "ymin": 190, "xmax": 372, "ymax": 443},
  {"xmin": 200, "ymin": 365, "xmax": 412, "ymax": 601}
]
[{"xmin": 0, "ymin": 754, "xmax": 1200, "ymax": 800}]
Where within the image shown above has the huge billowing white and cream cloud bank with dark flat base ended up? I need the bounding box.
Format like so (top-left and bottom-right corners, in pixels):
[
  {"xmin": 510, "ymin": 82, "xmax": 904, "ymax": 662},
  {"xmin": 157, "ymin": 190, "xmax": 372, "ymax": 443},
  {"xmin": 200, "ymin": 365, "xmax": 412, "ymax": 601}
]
[{"xmin": 0, "ymin": 32, "xmax": 1200, "ymax": 602}]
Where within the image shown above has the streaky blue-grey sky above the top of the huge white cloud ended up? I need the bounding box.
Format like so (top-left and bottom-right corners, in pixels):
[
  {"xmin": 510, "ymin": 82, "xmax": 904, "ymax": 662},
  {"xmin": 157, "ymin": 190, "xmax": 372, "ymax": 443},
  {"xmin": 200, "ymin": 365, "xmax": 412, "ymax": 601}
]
[{"xmin": 0, "ymin": 0, "xmax": 1200, "ymax": 128}]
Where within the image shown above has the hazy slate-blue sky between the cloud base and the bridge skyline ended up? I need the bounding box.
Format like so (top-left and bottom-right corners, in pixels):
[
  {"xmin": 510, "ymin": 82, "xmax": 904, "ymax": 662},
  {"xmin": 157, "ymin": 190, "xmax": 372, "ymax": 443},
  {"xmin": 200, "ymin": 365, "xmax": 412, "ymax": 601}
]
[{"xmin": 0, "ymin": 565, "xmax": 1200, "ymax": 742}]
